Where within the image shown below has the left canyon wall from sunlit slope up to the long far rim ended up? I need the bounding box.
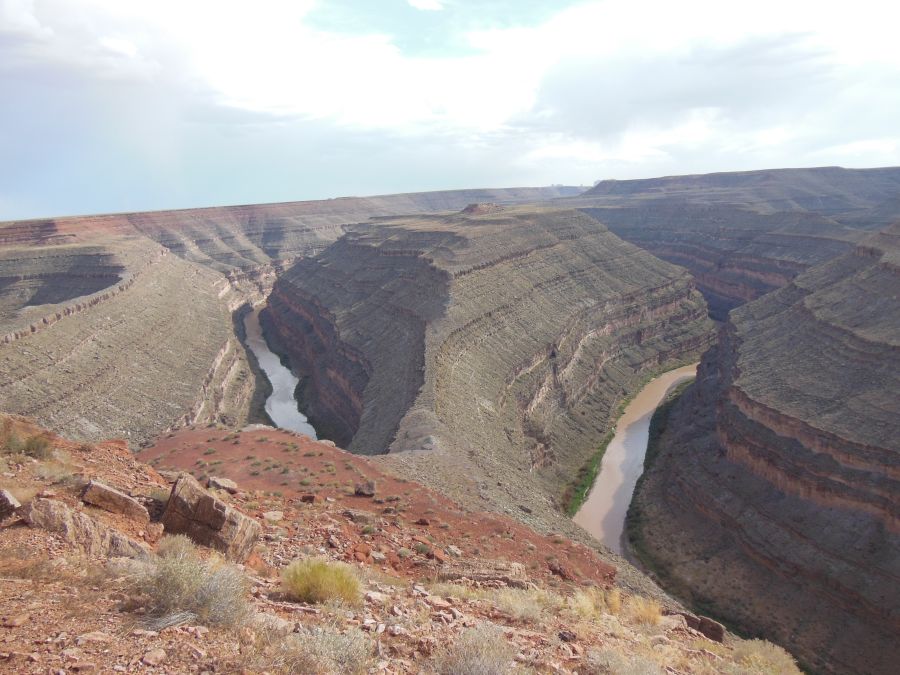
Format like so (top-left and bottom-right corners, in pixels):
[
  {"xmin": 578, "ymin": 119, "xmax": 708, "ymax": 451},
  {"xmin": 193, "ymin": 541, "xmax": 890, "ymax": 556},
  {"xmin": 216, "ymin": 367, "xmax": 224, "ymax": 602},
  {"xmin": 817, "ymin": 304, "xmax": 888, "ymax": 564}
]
[{"xmin": 0, "ymin": 187, "xmax": 578, "ymax": 444}]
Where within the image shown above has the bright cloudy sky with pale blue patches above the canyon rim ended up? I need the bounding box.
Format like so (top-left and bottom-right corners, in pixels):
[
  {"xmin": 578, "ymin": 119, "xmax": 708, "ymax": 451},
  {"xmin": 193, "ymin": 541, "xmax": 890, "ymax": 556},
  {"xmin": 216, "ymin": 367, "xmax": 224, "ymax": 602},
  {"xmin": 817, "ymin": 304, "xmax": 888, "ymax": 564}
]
[{"xmin": 0, "ymin": 0, "xmax": 900, "ymax": 220}]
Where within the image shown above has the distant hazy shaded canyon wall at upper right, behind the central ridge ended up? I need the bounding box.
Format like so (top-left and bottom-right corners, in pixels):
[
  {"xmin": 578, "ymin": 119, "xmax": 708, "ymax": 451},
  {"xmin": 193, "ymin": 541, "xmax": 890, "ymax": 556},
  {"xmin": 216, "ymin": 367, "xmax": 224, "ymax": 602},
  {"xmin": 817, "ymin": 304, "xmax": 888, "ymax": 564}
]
[{"xmin": 565, "ymin": 167, "xmax": 900, "ymax": 321}]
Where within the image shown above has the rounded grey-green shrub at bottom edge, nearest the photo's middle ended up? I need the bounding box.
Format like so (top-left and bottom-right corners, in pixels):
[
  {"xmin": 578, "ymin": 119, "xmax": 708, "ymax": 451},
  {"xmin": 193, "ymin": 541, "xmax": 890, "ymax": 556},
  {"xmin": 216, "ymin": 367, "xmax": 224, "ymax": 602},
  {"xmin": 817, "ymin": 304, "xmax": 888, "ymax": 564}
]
[{"xmin": 434, "ymin": 623, "xmax": 516, "ymax": 675}]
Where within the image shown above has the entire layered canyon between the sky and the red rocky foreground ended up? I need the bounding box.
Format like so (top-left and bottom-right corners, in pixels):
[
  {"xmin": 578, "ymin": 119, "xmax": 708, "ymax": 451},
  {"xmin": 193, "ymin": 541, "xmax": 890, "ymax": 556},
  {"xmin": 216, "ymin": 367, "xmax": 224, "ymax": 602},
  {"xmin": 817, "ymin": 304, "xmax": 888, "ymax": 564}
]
[{"xmin": 0, "ymin": 167, "xmax": 900, "ymax": 675}]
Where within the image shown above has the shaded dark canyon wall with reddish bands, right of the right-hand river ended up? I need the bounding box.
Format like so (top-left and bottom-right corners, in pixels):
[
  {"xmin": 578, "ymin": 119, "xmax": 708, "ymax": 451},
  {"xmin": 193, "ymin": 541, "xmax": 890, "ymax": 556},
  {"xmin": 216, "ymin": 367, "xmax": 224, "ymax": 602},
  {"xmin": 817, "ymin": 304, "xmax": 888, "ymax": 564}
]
[{"xmin": 631, "ymin": 225, "xmax": 900, "ymax": 675}]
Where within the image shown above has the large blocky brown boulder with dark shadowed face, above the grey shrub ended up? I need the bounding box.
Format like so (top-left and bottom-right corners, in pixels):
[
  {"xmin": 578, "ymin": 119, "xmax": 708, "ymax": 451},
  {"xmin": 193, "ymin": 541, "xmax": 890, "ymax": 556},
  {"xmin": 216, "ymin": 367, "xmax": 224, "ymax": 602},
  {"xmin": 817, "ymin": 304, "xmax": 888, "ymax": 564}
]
[{"xmin": 162, "ymin": 473, "xmax": 261, "ymax": 562}]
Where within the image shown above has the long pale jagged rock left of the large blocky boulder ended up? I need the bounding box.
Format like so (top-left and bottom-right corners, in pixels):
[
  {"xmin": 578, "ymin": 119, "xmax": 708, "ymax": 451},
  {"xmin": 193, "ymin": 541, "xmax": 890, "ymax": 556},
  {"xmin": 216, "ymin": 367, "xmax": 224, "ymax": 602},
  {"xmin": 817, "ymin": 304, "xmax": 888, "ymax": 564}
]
[{"xmin": 20, "ymin": 499, "xmax": 150, "ymax": 558}]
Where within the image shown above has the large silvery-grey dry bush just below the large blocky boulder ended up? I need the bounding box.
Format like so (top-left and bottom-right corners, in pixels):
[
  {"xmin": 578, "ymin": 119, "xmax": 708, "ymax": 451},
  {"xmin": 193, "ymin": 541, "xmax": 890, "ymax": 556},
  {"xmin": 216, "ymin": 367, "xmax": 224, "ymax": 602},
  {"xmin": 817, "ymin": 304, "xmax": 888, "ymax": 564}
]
[{"xmin": 134, "ymin": 535, "xmax": 249, "ymax": 630}]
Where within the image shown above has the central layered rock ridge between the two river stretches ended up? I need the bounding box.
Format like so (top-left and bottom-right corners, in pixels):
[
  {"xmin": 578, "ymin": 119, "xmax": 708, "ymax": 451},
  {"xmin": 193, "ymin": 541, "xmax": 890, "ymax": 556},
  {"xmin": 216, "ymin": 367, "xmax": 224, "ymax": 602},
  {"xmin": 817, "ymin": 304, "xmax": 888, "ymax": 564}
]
[{"xmin": 266, "ymin": 206, "xmax": 712, "ymax": 528}]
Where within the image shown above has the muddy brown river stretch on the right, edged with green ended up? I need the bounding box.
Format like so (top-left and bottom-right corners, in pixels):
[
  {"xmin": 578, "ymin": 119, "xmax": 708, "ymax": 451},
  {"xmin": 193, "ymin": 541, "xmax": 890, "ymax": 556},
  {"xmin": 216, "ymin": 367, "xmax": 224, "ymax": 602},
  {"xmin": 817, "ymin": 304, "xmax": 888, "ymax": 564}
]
[{"xmin": 574, "ymin": 363, "xmax": 697, "ymax": 554}]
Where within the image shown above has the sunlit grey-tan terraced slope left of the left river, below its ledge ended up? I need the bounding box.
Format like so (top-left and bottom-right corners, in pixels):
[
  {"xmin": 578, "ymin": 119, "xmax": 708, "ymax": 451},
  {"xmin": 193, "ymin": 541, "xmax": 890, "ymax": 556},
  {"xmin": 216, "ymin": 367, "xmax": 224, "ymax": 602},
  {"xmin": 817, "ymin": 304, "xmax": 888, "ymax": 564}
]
[{"xmin": 0, "ymin": 240, "xmax": 253, "ymax": 443}]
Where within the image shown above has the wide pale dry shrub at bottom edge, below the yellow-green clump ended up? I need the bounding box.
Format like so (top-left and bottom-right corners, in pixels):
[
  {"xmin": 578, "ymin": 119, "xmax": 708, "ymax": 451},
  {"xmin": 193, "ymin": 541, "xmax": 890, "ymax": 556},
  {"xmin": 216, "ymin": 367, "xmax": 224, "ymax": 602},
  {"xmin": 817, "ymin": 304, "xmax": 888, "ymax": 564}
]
[{"xmin": 247, "ymin": 626, "xmax": 372, "ymax": 675}]
